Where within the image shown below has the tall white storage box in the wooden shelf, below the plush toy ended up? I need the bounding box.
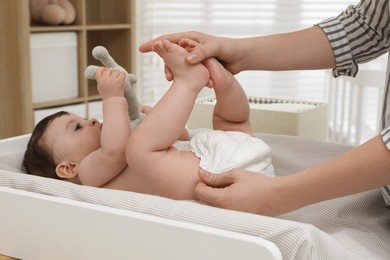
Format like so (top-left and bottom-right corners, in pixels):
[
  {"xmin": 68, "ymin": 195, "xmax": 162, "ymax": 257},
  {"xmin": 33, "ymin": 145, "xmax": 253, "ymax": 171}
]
[{"xmin": 30, "ymin": 32, "xmax": 79, "ymax": 103}]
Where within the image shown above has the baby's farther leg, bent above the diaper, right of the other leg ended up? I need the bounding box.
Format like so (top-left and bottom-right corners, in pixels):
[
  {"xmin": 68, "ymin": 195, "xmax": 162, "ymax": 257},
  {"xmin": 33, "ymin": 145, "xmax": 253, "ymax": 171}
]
[{"xmin": 204, "ymin": 58, "xmax": 252, "ymax": 134}]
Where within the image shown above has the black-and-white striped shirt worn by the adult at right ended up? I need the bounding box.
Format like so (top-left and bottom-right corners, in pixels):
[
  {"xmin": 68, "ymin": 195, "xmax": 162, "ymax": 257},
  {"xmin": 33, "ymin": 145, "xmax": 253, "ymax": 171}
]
[{"xmin": 318, "ymin": 0, "xmax": 390, "ymax": 208}]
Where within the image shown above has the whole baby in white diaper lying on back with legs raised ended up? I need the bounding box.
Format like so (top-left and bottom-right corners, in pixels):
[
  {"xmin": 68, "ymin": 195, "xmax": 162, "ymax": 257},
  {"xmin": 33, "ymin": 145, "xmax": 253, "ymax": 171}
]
[{"xmin": 23, "ymin": 40, "xmax": 273, "ymax": 199}]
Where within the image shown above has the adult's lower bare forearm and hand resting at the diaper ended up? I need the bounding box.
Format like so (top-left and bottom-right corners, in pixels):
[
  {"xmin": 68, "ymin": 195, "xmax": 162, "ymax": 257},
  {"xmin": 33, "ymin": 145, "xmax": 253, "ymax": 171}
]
[{"xmin": 195, "ymin": 136, "xmax": 390, "ymax": 216}]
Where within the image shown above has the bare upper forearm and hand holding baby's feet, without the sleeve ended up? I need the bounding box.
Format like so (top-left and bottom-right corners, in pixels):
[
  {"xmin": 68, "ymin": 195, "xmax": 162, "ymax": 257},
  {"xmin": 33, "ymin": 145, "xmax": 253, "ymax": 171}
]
[{"xmin": 140, "ymin": 26, "xmax": 335, "ymax": 74}]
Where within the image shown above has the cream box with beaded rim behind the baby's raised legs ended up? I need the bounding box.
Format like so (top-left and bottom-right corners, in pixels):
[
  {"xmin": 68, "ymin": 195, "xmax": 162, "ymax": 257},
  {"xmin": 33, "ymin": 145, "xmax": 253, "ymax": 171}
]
[{"xmin": 187, "ymin": 96, "xmax": 328, "ymax": 140}]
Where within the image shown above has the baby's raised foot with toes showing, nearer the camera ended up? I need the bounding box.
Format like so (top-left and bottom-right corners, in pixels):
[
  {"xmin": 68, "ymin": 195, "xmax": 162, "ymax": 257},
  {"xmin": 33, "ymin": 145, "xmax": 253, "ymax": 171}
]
[{"xmin": 152, "ymin": 40, "xmax": 210, "ymax": 89}]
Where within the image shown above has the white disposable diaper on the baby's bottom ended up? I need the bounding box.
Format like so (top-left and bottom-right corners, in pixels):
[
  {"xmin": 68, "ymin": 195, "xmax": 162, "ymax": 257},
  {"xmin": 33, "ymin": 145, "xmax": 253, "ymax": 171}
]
[{"xmin": 175, "ymin": 130, "xmax": 274, "ymax": 176}]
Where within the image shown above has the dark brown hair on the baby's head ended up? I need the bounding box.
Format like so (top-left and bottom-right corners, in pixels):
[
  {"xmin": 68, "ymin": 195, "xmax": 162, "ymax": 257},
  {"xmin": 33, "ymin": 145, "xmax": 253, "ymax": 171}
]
[{"xmin": 23, "ymin": 111, "xmax": 69, "ymax": 179}]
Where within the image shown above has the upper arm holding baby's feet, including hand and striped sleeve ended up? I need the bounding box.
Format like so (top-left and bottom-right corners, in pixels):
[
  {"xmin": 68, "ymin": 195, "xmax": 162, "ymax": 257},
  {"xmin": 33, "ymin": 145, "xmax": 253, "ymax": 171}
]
[{"xmin": 139, "ymin": 0, "xmax": 390, "ymax": 79}]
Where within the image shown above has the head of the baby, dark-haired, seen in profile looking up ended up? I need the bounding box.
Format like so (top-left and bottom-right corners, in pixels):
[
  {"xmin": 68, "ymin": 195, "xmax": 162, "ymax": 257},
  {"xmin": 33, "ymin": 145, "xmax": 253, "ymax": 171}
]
[{"xmin": 23, "ymin": 111, "xmax": 102, "ymax": 182}]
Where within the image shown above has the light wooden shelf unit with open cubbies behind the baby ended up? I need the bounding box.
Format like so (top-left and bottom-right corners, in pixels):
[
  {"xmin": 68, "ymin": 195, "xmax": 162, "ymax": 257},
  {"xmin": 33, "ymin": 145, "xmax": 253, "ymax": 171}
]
[{"xmin": 0, "ymin": 0, "xmax": 136, "ymax": 138}]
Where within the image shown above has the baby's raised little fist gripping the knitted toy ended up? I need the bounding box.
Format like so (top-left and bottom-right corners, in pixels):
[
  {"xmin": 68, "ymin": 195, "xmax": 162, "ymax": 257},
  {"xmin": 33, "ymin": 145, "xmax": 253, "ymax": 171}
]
[{"xmin": 95, "ymin": 67, "xmax": 126, "ymax": 99}]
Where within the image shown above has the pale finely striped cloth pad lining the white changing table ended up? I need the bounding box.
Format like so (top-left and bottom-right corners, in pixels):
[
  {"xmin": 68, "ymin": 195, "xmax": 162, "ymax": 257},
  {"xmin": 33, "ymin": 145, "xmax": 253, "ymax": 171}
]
[{"xmin": 0, "ymin": 135, "xmax": 390, "ymax": 260}]
